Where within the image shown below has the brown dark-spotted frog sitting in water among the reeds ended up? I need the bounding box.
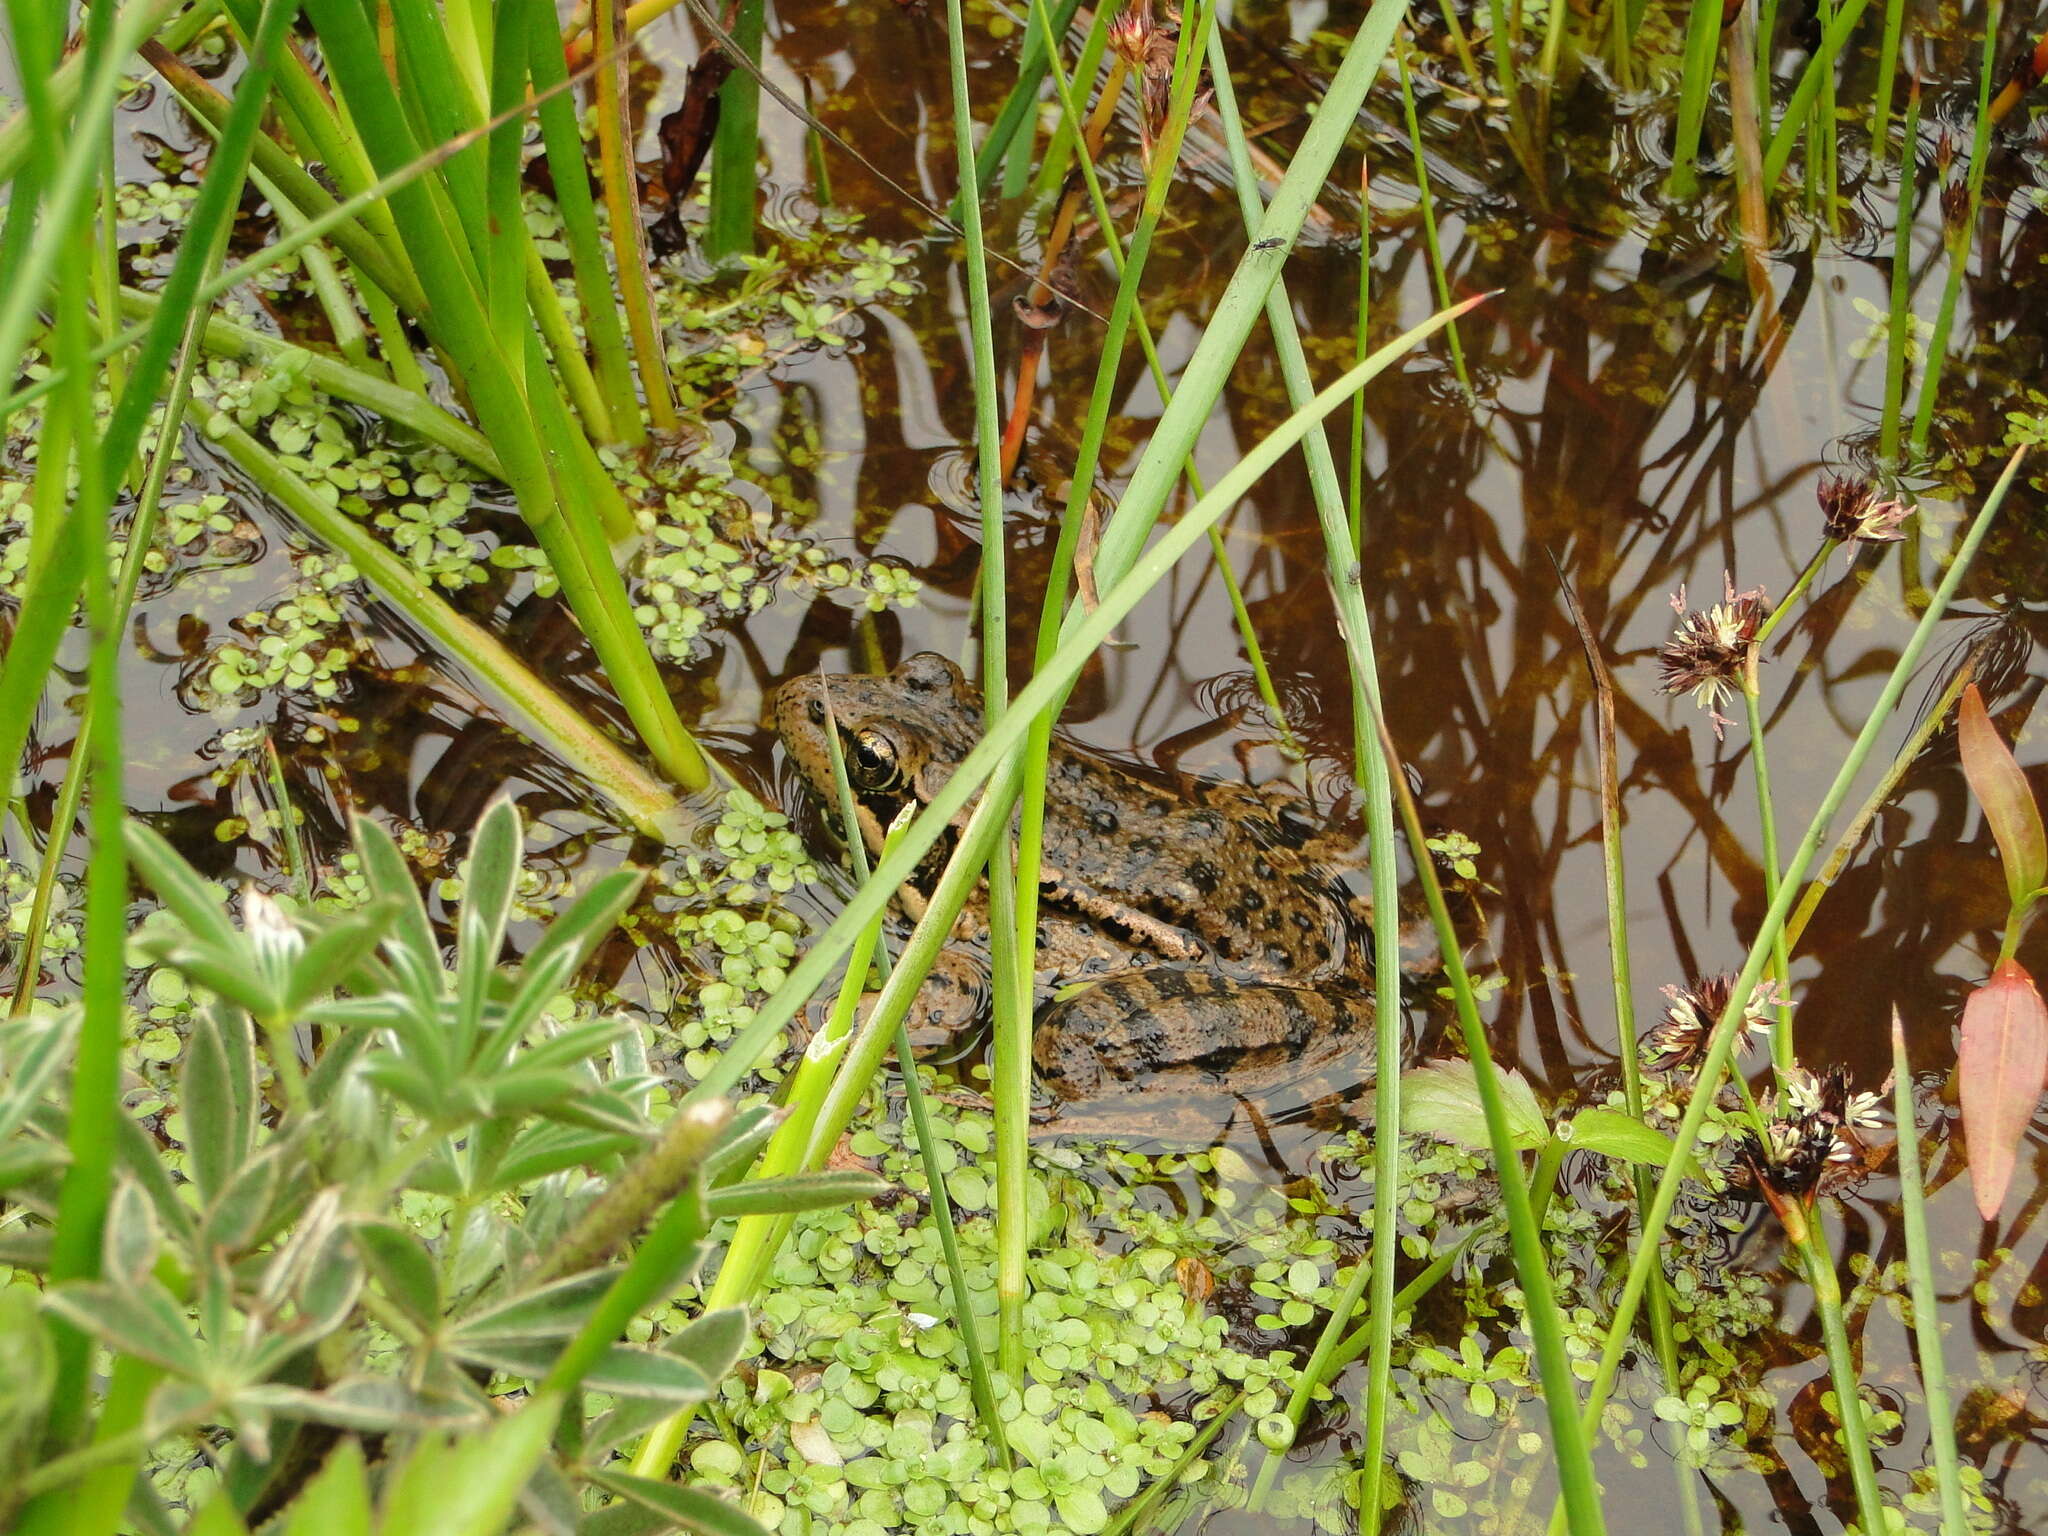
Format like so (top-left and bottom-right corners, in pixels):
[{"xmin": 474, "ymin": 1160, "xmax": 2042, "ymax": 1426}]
[{"xmin": 774, "ymin": 651, "xmax": 1372, "ymax": 1120}]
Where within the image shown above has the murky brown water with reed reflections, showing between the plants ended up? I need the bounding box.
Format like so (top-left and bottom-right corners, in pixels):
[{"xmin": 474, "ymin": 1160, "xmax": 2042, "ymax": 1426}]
[{"xmin": 16, "ymin": 0, "xmax": 2048, "ymax": 1532}]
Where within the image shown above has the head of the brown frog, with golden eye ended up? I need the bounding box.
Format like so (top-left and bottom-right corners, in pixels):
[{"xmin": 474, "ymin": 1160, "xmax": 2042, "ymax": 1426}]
[{"xmin": 774, "ymin": 651, "xmax": 981, "ymax": 852}]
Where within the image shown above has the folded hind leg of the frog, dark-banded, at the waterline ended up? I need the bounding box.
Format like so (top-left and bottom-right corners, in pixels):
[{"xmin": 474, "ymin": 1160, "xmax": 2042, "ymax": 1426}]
[{"xmin": 1032, "ymin": 967, "xmax": 1372, "ymax": 1102}]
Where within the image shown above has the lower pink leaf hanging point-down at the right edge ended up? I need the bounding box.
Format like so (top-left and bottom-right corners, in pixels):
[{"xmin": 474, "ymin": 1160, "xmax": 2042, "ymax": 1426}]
[{"xmin": 1956, "ymin": 961, "xmax": 2048, "ymax": 1221}]
